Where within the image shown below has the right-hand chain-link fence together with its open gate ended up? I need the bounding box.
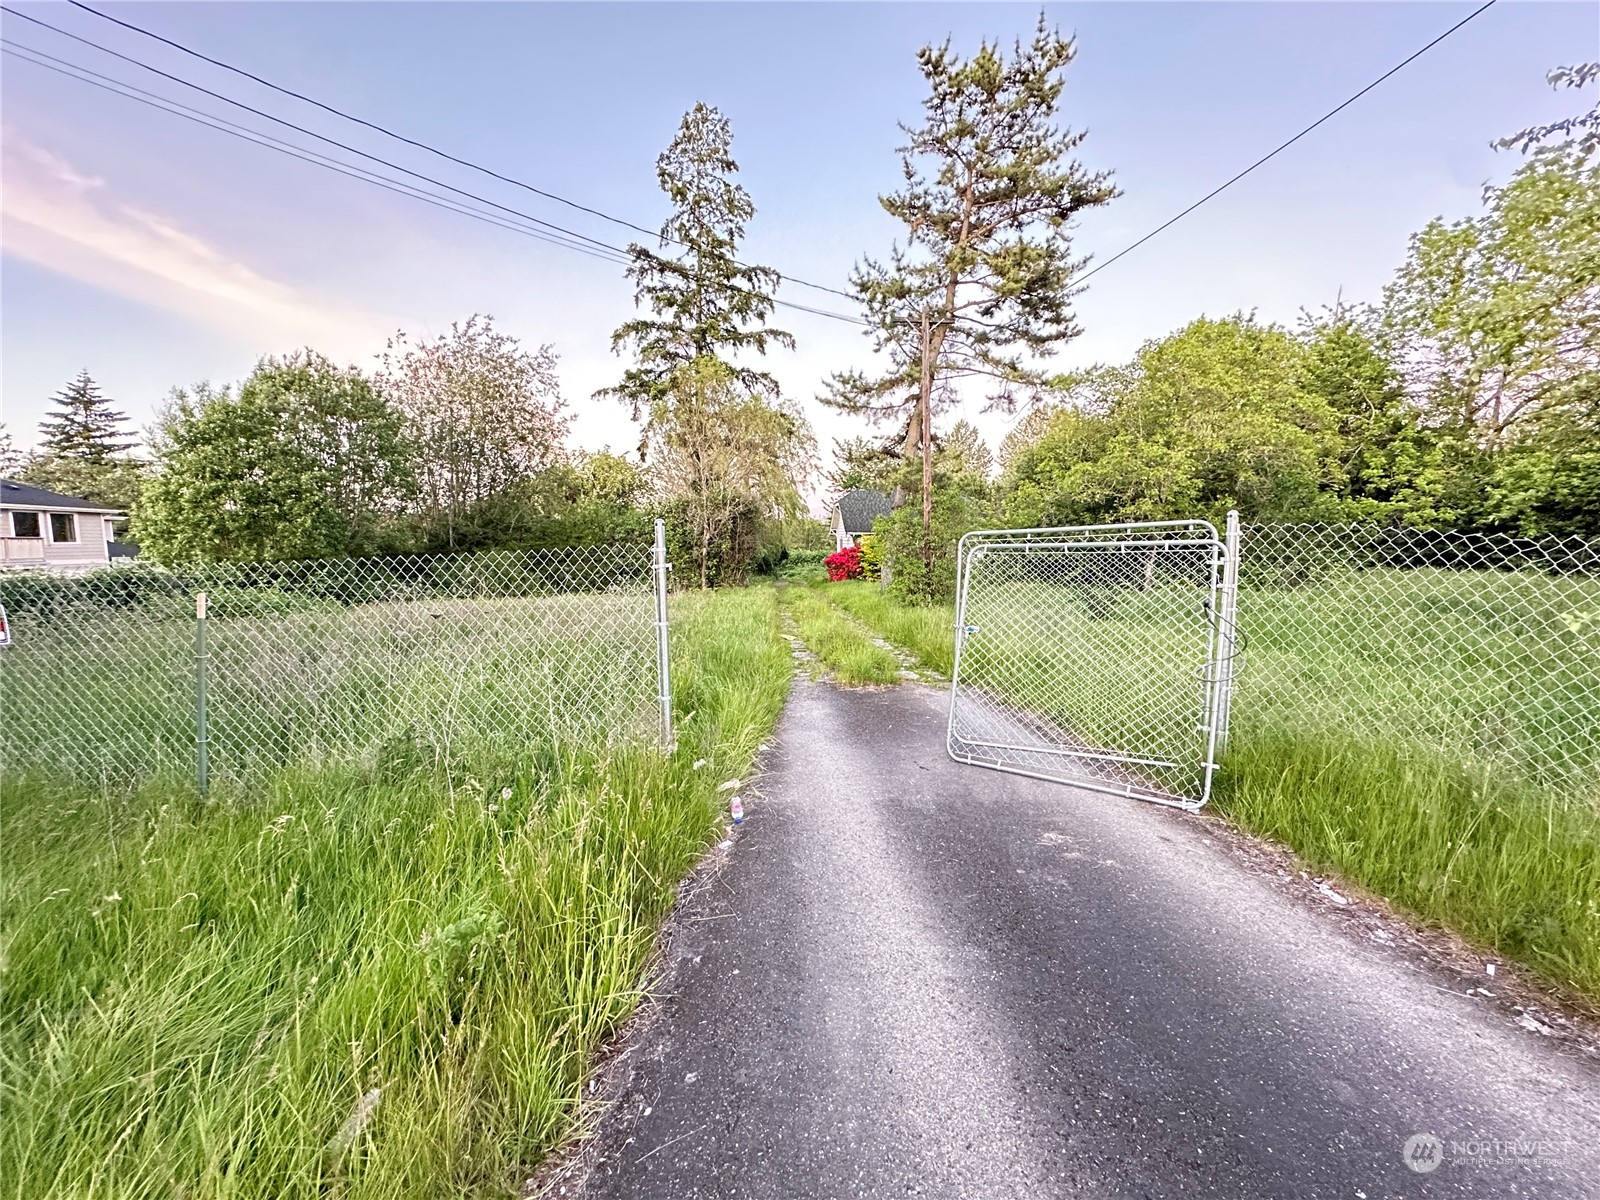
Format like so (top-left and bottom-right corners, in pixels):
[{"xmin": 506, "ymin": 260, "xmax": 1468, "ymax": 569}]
[{"xmin": 949, "ymin": 523, "xmax": 1600, "ymax": 806}]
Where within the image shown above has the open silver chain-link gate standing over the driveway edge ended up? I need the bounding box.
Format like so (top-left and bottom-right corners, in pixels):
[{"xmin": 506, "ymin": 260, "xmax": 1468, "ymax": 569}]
[{"xmin": 947, "ymin": 514, "xmax": 1238, "ymax": 810}]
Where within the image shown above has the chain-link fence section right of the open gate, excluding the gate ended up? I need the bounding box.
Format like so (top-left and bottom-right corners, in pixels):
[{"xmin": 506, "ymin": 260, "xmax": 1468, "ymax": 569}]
[{"xmin": 1232, "ymin": 523, "xmax": 1600, "ymax": 798}]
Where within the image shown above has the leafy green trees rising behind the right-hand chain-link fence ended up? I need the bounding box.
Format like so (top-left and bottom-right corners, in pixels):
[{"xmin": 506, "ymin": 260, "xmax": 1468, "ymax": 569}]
[{"xmin": 998, "ymin": 150, "xmax": 1600, "ymax": 536}]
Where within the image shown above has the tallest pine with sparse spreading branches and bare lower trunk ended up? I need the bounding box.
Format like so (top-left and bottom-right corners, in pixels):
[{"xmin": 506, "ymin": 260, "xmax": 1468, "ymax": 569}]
[{"xmin": 822, "ymin": 14, "xmax": 1117, "ymax": 565}]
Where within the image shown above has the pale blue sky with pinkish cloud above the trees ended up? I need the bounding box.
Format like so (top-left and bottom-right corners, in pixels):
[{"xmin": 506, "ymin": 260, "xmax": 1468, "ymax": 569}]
[{"xmin": 0, "ymin": 0, "xmax": 1600, "ymax": 494}]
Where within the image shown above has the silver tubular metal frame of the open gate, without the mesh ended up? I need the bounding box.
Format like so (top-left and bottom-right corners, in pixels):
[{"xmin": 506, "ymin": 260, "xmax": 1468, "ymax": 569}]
[{"xmin": 946, "ymin": 512, "xmax": 1238, "ymax": 811}]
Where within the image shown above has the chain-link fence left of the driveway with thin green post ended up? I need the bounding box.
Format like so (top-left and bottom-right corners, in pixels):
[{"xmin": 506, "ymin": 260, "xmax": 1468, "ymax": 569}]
[{"xmin": 0, "ymin": 538, "xmax": 670, "ymax": 787}]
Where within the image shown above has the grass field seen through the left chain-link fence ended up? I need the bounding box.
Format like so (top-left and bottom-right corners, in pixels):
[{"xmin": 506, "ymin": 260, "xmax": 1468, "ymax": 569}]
[{"xmin": 0, "ymin": 582, "xmax": 656, "ymax": 787}]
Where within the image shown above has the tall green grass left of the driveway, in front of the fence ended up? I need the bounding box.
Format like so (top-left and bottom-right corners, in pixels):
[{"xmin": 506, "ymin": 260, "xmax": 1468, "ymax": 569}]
[{"xmin": 0, "ymin": 589, "xmax": 792, "ymax": 1200}]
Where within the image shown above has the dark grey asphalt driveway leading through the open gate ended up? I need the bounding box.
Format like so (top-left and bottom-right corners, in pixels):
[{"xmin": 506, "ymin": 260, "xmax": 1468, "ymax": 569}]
[{"xmin": 552, "ymin": 680, "xmax": 1600, "ymax": 1200}]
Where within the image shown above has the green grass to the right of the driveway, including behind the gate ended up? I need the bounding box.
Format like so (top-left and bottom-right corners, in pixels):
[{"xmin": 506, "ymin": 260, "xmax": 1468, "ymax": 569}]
[{"xmin": 824, "ymin": 570, "xmax": 1600, "ymax": 1000}]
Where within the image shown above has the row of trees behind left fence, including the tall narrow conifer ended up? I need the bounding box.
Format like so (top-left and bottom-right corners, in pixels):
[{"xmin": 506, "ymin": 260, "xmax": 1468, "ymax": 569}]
[{"xmin": 5, "ymin": 104, "xmax": 827, "ymax": 586}]
